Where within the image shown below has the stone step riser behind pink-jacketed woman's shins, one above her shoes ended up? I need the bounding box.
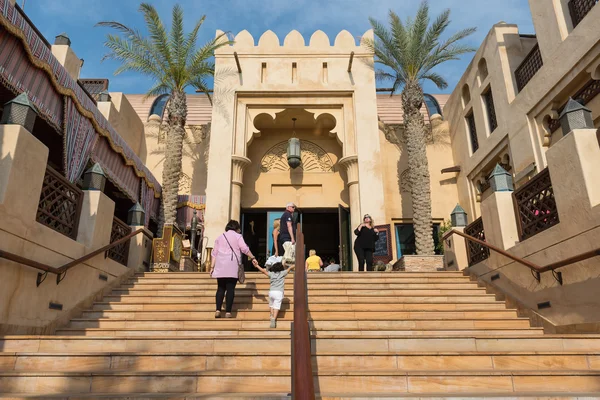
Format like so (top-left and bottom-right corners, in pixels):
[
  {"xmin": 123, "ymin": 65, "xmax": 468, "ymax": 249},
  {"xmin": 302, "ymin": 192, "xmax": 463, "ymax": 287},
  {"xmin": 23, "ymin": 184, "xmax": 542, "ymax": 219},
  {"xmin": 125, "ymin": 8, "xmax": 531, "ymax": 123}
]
[{"xmin": 103, "ymin": 291, "xmax": 497, "ymax": 304}]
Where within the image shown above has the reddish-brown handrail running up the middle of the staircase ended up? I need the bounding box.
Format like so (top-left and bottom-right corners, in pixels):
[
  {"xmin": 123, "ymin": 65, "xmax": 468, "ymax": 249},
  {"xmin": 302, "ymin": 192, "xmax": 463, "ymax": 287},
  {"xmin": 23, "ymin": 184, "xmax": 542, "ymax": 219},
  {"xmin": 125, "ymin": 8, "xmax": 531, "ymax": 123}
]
[{"xmin": 291, "ymin": 224, "xmax": 315, "ymax": 400}]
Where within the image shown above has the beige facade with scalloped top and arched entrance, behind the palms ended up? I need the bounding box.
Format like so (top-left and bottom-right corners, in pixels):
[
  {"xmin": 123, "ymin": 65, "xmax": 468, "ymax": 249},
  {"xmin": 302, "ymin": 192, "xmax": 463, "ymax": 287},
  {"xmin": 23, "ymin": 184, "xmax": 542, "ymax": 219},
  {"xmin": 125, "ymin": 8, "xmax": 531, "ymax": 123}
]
[{"xmin": 126, "ymin": 31, "xmax": 458, "ymax": 269}]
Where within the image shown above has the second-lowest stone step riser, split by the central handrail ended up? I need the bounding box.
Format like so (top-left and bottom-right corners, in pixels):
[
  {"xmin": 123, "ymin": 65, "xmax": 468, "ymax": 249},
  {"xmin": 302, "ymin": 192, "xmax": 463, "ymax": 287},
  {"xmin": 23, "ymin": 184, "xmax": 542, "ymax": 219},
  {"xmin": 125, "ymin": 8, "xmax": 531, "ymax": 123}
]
[{"xmin": 0, "ymin": 351, "xmax": 600, "ymax": 372}]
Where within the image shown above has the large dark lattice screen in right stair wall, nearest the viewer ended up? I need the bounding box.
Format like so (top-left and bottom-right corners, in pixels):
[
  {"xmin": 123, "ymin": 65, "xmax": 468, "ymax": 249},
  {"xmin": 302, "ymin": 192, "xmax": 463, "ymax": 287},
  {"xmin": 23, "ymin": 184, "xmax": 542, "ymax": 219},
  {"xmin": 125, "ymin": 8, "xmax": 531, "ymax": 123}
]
[{"xmin": 513, "ymin": 168, "xmax": 560, "ymax": 240}]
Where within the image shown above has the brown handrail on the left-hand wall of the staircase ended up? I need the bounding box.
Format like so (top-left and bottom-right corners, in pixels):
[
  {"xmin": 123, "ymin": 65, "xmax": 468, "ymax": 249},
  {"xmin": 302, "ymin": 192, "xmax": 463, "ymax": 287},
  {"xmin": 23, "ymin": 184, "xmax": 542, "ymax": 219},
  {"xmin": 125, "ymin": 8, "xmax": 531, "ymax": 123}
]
[{"xmin": 0, "ymin": 228, "xmax": 152, "ymax": 286}]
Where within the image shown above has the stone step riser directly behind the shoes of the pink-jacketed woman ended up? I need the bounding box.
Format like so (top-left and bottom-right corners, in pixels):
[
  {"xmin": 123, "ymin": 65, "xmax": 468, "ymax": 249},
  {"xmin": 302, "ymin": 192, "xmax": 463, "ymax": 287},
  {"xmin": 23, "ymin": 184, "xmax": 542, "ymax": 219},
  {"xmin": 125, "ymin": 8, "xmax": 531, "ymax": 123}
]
[{"xmin": 92, "ymin": 299, "xmax": 506, "ymax": 312}]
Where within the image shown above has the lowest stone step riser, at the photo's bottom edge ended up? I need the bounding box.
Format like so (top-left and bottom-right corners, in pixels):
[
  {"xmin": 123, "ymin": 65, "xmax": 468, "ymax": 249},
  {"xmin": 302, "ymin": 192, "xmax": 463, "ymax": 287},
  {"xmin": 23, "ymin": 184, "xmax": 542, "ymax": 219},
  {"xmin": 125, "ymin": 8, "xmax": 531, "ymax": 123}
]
[{"xmin": 0, "ymin": 370, "xmax": 600, "ymax": 396}]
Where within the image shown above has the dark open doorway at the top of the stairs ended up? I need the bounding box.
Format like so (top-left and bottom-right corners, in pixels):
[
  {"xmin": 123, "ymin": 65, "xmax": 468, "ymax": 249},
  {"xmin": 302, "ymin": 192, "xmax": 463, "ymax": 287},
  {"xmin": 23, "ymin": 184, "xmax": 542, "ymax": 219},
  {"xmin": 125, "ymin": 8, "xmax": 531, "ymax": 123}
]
[{"xmin": 241, "ymin": 207, "xmax": 352, "ymax": 271}]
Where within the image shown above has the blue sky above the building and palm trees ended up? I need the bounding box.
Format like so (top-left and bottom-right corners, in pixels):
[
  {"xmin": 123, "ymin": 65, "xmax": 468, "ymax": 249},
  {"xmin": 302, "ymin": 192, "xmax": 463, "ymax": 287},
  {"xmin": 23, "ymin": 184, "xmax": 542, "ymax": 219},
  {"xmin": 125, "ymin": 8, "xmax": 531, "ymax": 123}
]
[{"xmin": 22, "ymin": 0, "xmax": 534, "ymax": 93}]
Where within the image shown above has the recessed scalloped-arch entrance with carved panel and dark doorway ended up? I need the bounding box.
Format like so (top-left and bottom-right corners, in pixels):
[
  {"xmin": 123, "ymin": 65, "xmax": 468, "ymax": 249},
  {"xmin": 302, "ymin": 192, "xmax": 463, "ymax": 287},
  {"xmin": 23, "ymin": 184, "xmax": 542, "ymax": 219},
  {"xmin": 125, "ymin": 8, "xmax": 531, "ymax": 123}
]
[{"xmin": 240, "ymin": 108, "xmax": 352, "ymax": 269}]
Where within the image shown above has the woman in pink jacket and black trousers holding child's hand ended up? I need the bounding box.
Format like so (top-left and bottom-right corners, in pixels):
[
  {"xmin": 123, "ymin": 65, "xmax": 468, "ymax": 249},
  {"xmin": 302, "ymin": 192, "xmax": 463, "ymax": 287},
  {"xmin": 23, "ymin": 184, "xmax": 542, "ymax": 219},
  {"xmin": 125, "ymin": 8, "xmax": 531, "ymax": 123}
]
[{"xmin": 210, "ymin": 220, "xmax": 258, "ymax": 318}]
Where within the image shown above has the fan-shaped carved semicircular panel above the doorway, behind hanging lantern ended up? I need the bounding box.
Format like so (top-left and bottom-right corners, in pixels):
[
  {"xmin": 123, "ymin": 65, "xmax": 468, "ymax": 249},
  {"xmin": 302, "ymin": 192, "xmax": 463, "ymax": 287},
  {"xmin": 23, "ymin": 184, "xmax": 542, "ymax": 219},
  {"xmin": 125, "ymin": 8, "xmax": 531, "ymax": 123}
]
[{"xmin": 260, "ymin": 140, "xmax": 333, "ymax": 172}]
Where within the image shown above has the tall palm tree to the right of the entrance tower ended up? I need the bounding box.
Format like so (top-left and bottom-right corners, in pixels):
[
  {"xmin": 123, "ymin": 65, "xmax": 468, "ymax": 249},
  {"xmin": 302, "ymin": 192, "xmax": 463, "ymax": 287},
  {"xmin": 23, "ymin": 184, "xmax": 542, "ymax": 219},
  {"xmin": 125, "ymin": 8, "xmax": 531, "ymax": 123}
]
[{"xmin": 366, "ymin": 0, "xmax": 475, "ymax": 255}]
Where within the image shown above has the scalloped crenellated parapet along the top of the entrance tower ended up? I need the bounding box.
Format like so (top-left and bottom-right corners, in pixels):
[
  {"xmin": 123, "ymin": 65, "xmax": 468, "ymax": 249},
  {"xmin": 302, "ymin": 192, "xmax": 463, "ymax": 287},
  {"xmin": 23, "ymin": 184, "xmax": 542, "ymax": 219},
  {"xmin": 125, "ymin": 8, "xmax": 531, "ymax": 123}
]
[{"xmin": 216, "ymin": 29, "xmax": 373, "ymax": 54}]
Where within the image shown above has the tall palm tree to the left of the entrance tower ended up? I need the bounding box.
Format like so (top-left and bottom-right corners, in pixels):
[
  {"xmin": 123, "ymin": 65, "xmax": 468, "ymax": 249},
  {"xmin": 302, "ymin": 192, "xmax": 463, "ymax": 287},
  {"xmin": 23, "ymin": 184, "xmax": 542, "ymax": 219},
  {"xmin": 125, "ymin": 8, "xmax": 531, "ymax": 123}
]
[{"xmin": 97, "ymin": 3, "xmax": 231, "ymax": 235}]
